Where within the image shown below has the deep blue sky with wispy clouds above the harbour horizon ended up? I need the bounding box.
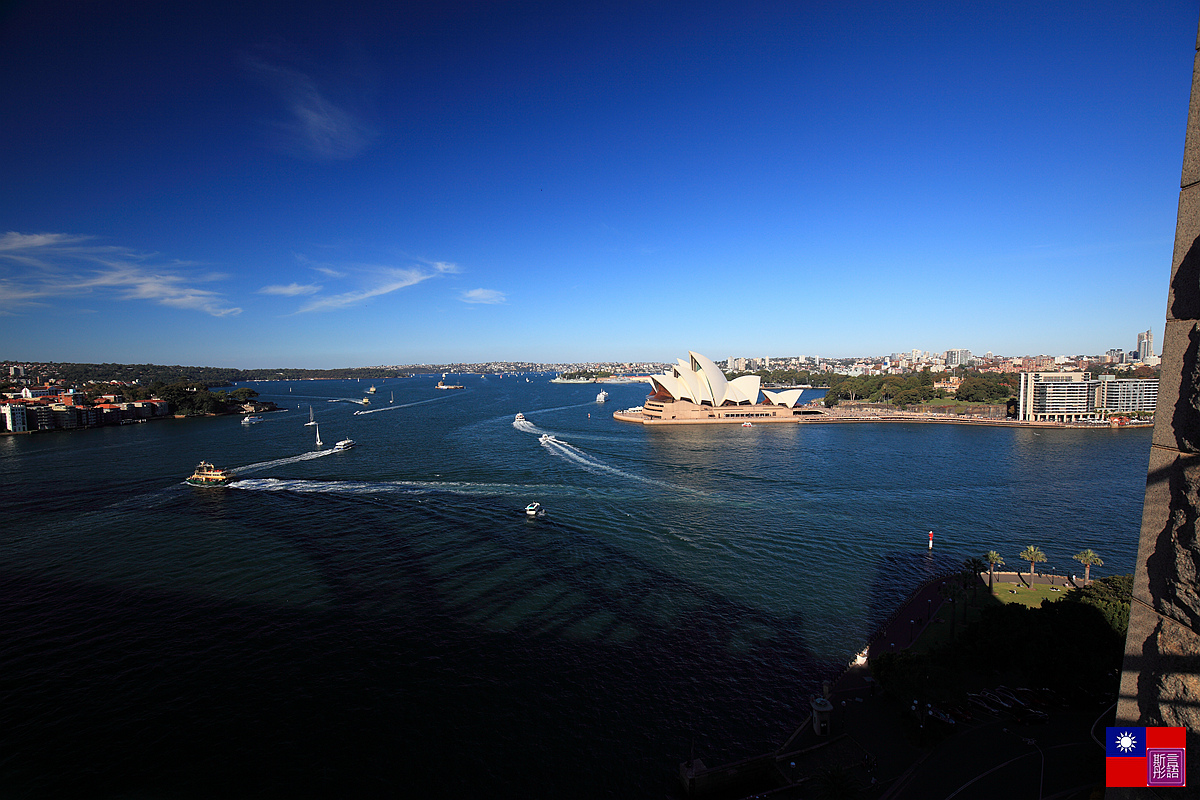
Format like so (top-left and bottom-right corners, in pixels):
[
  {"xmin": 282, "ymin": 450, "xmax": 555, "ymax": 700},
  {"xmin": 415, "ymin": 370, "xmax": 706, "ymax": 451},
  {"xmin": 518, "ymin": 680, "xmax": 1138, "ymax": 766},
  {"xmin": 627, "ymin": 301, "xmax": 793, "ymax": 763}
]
[{"xmin": 0, "ymin": 0, "xmax": 1200, "ymax": 368}]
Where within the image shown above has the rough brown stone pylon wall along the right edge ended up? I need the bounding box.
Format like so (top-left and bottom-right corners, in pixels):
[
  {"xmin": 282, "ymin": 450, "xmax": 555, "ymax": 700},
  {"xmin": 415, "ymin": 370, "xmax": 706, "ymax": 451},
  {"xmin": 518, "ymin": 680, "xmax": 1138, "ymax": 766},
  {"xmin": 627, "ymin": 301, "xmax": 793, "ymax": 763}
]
[{"xmin": 1106, "ymin": 17, "xmax": 1200, "ymax": 798}]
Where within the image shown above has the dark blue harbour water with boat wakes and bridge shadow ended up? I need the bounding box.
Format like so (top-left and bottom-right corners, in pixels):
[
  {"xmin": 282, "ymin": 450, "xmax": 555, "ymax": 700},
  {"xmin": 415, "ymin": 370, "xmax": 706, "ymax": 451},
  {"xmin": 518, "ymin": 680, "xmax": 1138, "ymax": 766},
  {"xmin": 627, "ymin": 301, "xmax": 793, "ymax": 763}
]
[{"xmin": 0, "ymin": 375, "xmax": 1150, "ymax": 798}]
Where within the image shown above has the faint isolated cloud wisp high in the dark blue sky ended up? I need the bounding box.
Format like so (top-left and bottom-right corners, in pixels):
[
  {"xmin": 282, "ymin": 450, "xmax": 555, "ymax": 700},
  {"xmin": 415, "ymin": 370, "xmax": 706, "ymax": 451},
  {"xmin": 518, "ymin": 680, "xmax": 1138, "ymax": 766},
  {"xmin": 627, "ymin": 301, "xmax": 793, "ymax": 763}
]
[{"xmin": 245, "ymin": 58, "xmax": 376, "ymax": 161}]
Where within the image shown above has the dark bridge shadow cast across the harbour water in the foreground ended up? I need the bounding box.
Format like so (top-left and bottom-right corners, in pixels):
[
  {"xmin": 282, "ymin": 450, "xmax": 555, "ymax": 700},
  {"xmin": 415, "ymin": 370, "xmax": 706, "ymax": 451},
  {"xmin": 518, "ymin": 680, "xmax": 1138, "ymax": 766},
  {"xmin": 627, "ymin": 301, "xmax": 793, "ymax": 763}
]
[{"xmin": 0, "ymin": 484, "xmax": 854, "ymax": 798}]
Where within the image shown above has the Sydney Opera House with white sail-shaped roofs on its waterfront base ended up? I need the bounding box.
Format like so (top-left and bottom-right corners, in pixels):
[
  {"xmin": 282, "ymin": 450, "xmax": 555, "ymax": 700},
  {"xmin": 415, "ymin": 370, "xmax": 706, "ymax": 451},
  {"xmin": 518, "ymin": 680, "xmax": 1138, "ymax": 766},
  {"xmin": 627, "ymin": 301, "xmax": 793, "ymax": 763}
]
[{"xmin": 613, "ymin": 351, "xmax": 818, "ymax": 425}]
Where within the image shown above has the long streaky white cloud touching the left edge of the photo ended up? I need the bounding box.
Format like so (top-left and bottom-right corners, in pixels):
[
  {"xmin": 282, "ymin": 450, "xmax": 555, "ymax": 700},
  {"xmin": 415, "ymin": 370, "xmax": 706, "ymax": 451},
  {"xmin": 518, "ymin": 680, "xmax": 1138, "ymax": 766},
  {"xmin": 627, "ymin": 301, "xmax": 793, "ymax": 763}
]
[{"xmin": 0, "ymin": 231, "xmax": 241, "ymax": 317}]
